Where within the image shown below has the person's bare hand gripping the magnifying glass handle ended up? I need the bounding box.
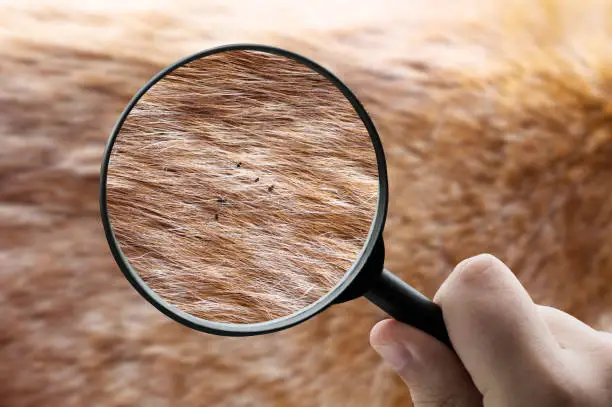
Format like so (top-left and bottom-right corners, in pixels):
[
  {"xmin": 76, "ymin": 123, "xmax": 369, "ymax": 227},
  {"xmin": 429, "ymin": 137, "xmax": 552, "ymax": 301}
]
[{"xmin": 370, "ymin": 254, "xmax": 612, "ymax": 407}]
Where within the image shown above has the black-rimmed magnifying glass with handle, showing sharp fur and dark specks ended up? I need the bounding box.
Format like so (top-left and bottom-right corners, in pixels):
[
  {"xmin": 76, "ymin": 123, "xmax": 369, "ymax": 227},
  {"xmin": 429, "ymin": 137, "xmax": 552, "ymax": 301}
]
[{"xmin": 100, "ymin": 45, "xmax": 451, "ymax": 346}]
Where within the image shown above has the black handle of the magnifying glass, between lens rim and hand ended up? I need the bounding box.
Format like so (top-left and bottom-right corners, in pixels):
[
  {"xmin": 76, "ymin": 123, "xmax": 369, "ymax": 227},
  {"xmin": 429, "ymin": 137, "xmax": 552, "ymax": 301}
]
[{"xmin": 365, "ymin": 269, "xmax": 453, "ymax": 349}]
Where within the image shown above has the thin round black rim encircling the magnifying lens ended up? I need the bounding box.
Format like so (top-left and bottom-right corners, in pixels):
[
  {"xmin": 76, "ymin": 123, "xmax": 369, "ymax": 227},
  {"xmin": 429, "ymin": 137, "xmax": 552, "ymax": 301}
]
[{"xmin": 100, "ymin": 44, "xmax": 388, "ymax": 336}]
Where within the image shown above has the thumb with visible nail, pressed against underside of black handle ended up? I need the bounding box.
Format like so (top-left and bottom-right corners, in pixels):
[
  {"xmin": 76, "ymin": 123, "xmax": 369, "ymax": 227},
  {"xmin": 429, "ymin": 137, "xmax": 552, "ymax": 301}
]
[{"xmin": 370, "ymin": 319, "xmax": 482, "ymax": 407}]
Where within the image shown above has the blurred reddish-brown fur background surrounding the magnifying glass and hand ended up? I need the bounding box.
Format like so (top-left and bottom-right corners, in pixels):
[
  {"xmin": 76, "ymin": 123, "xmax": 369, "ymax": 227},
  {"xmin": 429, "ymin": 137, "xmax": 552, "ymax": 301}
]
[{"xmin": 0, "ymin": 0, "xmax": 612, "ymax": 407}]
